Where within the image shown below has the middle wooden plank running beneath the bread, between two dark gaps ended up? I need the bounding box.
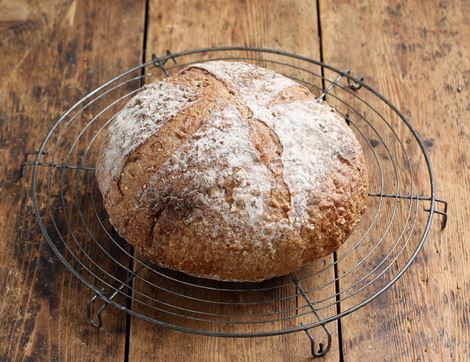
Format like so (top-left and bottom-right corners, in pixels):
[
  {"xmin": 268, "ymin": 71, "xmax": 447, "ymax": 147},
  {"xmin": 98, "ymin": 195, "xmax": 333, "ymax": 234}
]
[{"xmin": 129, "ymin": 0, "xmax": 339, "ymax": 361}]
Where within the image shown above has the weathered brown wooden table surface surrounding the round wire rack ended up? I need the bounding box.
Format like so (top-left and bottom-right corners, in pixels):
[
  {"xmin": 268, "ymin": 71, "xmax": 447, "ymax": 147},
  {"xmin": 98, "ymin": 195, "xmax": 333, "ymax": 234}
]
[{"xmin": 0, "ymin": 0, "xmax": 470, "ymax": 361}]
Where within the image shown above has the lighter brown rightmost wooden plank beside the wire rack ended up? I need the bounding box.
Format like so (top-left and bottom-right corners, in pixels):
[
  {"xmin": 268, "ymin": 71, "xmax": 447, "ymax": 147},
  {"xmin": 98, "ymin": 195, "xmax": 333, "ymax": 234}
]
[{"xmin": 320, "ymin": 0, "xmax": 470, "ymax": 361}]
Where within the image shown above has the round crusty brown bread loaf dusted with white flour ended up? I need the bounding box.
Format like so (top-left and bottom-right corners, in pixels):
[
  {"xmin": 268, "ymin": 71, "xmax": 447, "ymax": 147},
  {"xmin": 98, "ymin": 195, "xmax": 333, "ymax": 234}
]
[{"xmin": 96, "ymin": 61, "xmax": 368, "ymax": 281}]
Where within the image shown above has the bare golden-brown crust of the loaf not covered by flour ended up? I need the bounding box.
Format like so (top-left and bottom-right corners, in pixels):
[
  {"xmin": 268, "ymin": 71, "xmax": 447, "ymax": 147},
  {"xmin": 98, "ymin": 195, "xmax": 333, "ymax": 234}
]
[{"xmin": 96, "ymin": 63, "xmax": 368, "ymax": 281}]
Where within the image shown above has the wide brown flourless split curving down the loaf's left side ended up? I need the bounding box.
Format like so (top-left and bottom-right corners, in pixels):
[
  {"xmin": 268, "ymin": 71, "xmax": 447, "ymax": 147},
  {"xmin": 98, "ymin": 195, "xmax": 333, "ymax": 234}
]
[{"xmin": 98, "ymin": 68, "xmax": 239, "ymax": 244}]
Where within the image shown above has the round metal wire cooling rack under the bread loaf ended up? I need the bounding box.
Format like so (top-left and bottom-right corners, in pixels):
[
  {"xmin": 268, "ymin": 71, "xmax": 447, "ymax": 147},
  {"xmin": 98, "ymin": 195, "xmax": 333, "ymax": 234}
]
[{"xmin": 29, "ymin": 47, "xmax": 447, "ymax": 356}]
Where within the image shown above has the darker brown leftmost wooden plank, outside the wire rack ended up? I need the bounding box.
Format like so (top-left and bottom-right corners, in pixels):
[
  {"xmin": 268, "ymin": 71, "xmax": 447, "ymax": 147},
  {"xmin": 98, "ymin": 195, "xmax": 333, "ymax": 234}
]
[{"xmin": 0, "ymin": 0, "xmax": 145, "ymax": 361}]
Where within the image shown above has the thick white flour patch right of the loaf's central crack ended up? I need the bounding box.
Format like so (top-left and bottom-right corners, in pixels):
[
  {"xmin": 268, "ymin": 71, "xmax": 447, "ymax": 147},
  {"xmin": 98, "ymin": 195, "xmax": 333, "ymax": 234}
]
[{"xmin": 192, "ymin": 61, "xmax": 358, "ymax": 221}]
